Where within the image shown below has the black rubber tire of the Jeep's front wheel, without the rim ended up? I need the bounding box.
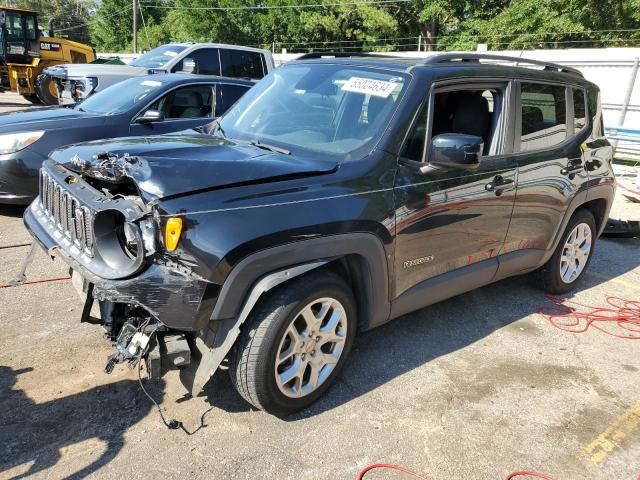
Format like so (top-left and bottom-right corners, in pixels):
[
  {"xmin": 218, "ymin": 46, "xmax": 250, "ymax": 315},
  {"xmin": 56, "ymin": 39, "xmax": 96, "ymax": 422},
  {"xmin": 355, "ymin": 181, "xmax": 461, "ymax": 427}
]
[{"xmin": 229, "ymin": 271, "xmax": 357, "ymax": 416}]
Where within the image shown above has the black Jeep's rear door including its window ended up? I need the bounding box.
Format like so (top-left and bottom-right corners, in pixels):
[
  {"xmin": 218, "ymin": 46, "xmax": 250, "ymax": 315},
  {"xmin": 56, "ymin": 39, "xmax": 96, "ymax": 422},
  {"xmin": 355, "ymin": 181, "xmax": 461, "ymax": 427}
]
[{"xmin": 502, "ymin": 80, "xmax": 587, "ymax": 266}]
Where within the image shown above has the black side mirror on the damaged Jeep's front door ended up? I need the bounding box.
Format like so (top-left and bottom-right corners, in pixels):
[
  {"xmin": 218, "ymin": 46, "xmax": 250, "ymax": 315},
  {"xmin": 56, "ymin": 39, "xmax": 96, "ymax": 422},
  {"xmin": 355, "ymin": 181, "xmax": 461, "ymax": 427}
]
[{"xmin": 429, "ymin": 133, "xmax": 484, "ymax": 170}]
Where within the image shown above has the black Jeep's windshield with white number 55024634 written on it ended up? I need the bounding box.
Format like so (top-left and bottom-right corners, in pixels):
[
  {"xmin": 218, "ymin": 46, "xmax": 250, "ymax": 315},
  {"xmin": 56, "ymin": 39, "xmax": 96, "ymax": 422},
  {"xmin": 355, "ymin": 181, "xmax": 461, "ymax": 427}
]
[{"xmin": 219, "ymin": 64, "xmax": 407, "ymax": 156}]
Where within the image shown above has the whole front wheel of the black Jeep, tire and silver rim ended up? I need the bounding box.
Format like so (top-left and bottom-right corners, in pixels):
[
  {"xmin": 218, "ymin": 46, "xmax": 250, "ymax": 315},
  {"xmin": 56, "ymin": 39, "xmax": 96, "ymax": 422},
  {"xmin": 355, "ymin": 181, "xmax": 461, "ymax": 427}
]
[{"xmin": 229, "ymin": 272, "xmax": 357, "ymax": 415}]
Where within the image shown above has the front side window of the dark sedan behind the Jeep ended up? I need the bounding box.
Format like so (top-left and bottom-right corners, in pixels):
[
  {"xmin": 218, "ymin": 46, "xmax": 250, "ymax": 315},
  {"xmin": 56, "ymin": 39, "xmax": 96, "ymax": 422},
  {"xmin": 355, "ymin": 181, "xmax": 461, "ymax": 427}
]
[{"xmin": 149, "ymin": 85, "xmax": 213, "ymax": 119}]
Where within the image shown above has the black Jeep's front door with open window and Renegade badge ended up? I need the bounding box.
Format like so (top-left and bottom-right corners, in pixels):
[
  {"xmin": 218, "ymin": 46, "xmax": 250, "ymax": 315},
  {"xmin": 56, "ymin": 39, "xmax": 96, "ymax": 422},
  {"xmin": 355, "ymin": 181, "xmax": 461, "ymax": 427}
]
[{"xmin": 394, "ymin": 82, "xmax": 517, "ymax": 303}]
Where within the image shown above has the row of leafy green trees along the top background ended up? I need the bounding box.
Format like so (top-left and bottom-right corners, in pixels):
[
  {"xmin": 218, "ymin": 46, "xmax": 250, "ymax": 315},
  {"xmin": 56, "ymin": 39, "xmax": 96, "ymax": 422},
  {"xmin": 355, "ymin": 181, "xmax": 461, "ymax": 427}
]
[{"xmin": 31, "ymin": 0, "xmax": 640, "ymax": 52}]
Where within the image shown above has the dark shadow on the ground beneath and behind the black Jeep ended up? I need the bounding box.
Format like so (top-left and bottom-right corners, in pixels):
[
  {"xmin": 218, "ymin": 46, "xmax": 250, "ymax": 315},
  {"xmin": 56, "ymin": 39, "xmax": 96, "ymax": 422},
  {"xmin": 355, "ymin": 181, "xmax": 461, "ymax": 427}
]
[{"xmin": 205, "ymin": 239, "xmax": 640, "ymax": 421}]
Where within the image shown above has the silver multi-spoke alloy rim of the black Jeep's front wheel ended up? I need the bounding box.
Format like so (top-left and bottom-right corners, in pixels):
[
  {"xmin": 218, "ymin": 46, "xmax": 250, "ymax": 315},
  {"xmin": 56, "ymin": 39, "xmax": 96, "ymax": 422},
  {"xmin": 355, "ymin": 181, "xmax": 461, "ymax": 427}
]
[{"xmin": 275, "ymin": 297, "xmax": 347, "ymax": 398}]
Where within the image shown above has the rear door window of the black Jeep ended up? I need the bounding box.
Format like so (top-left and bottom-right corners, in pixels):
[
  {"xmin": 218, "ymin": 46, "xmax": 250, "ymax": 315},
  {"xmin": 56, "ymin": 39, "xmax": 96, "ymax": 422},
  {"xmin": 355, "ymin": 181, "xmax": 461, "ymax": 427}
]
[{"xmin": 520, "ymin": 83, "xmax": 567, "ymax": 152}]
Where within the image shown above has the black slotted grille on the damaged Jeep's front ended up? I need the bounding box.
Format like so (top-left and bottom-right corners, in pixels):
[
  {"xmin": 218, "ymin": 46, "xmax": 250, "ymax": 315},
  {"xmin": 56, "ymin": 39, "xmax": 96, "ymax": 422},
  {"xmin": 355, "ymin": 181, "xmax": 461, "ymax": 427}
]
[{"xmin": 40, "ymin": 170, "xmax": 93, "ymax": 255}]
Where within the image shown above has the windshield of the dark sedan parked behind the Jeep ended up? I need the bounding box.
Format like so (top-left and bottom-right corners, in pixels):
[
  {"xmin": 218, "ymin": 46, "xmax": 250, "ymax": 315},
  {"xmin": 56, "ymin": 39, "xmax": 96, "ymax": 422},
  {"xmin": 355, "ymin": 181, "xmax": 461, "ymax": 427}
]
[{"xmin": 74, "ymin": 76, "xmax": 163, "ymax": 115}]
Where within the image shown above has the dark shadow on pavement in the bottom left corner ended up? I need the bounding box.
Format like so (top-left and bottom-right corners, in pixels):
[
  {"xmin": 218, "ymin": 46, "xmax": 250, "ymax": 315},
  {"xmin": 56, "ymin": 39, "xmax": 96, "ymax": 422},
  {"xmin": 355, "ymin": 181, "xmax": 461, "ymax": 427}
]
[{"xmin": 0, "ymin": 365, "xmax": 164, "ymax": 480}]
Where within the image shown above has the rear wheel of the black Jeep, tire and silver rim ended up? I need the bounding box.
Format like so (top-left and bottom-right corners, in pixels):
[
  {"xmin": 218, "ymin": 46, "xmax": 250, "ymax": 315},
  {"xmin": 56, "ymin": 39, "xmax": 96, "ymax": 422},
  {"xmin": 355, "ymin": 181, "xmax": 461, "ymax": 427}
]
[{"xmin": 536, "ymin": 210, "xmax": 596, "ymax": 293}]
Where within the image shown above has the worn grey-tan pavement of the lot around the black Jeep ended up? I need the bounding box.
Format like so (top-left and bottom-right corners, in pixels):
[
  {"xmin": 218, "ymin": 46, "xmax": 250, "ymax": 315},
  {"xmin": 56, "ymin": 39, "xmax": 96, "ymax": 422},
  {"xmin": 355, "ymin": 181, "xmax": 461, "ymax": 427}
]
[{"xmin": 0, "ymin": 94, "xmax": 640, "ymax": 480}]
